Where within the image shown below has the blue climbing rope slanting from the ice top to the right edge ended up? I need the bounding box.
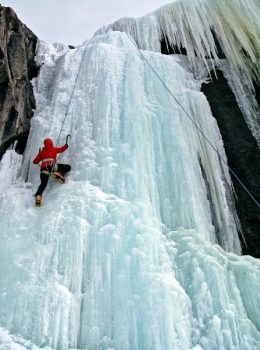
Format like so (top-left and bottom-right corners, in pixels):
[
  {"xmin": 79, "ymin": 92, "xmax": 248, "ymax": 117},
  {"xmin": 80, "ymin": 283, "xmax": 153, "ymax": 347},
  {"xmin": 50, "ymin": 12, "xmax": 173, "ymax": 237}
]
[{"xmin": 112, "ymin": 21, "xmax": 260, "ymax": 209}]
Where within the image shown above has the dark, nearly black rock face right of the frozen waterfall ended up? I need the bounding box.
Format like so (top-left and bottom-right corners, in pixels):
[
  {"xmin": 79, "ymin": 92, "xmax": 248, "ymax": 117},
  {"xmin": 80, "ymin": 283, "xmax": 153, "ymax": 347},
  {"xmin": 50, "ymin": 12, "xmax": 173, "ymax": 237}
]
[{"xmin": 202, "ymin": 71, "xmax": 260, "ymax": 258}]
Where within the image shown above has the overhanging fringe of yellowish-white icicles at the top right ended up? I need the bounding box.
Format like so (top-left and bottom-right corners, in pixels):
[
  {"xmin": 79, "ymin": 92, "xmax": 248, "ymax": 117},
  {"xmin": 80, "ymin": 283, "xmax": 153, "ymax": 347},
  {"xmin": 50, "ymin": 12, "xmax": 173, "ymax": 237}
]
[{"xmin": 99, "ymin": 0, "xmax": 260, "ymax": 145}]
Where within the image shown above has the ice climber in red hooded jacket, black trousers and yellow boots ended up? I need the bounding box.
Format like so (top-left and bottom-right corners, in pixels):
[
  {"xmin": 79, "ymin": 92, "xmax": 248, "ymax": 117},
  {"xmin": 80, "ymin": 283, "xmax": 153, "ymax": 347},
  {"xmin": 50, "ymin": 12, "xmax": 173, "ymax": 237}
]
[{"xmin": 33, "ymin": 138, "xmax": 71, "ymax": 207}]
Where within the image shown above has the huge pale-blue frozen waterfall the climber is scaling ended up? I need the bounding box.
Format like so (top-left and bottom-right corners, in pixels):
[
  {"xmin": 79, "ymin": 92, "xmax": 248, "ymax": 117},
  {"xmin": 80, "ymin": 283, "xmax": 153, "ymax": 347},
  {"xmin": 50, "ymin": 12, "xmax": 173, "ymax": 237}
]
[{"xmin": 0, "ymin": 32, "xmax": 260, "ymax": 350}]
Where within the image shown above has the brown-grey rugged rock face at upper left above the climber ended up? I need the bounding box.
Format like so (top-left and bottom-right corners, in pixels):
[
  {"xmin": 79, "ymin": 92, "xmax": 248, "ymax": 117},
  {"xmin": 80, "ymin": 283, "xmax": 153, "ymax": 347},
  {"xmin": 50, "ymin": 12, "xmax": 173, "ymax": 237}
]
[{"xmin": 0, "ymin": 5, "xmax": 38, "ymax": 159}]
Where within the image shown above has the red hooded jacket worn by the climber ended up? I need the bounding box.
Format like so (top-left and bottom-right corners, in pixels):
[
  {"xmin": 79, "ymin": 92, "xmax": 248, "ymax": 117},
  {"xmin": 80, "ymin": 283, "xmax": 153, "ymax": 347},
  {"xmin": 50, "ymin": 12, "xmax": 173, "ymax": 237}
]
[{"xmin": 33, "ymin": 139, "xmax": 69, "ymax": 169}]
